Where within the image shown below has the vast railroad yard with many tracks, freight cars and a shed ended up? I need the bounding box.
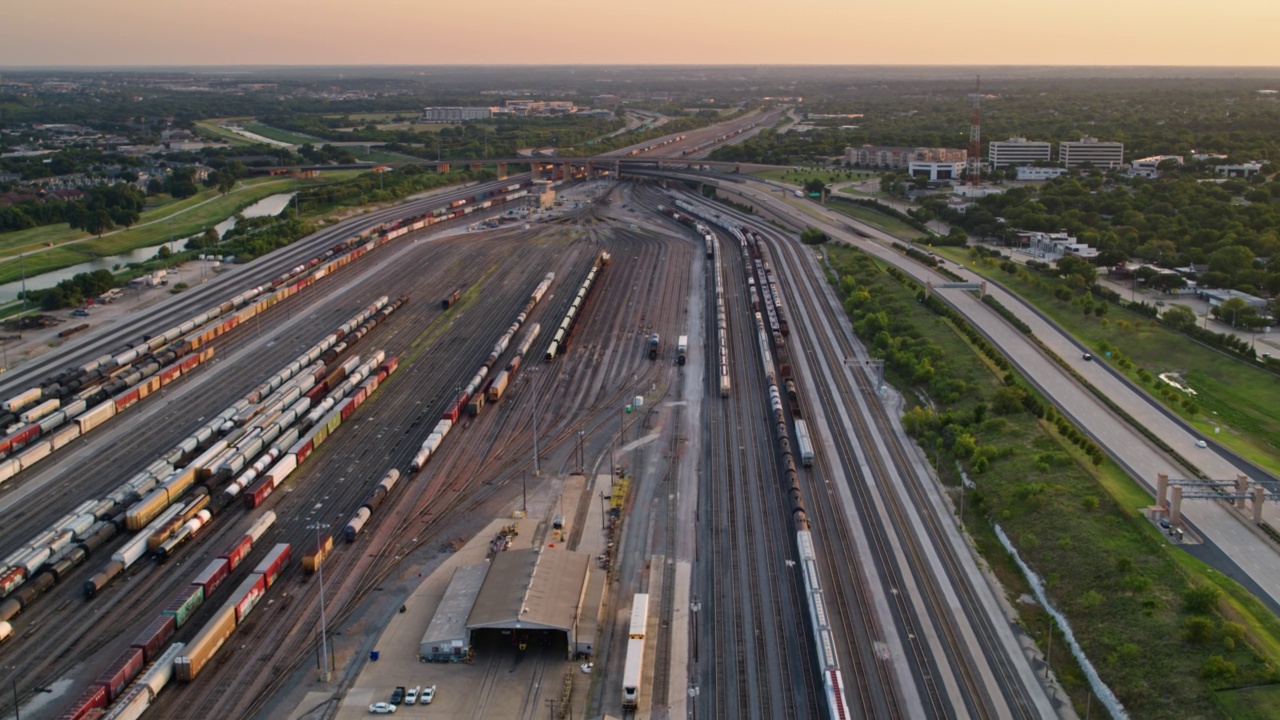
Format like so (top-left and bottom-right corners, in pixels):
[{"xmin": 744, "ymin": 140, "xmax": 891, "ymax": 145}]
[{"xmin": 0, "ymin": 107, "xmax": 1050, "ymax": 720}]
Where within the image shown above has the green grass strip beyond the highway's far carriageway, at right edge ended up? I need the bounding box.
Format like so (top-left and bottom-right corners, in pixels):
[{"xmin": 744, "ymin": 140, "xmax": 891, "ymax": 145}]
[{"xmin": 952, "ymin": 249, "xmax": 1280, "ymax": 473}]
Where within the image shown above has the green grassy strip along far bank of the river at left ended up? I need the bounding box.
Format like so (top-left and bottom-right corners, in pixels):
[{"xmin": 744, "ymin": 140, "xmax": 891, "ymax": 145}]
[{"xmin": 0, "ymin": 170, "xmax": 364, "ymax": 282}]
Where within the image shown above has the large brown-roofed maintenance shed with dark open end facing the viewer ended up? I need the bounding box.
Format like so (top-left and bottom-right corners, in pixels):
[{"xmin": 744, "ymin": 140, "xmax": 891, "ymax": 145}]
[{"xmin": 467, "ymin": 547, "xmax": 596, "ymax": 657}]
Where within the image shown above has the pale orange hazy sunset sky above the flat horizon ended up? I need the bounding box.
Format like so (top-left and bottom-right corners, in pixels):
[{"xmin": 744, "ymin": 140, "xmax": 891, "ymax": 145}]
[{"xmin": 0, "ymin": 0, "xmax": 1280, "ymax": 67}]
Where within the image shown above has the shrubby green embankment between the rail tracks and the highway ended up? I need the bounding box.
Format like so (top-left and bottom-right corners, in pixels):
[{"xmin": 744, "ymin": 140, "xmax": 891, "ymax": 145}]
[{"xmin": 828, "ymin": 247, "xmax": 1280, "ymax": 717}]
